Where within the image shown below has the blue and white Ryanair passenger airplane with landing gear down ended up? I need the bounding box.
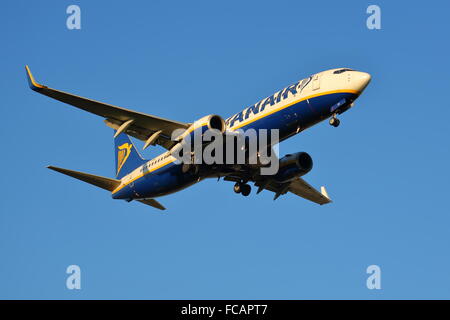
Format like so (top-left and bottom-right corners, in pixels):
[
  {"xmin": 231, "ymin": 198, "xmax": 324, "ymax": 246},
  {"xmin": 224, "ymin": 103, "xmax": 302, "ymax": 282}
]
[{"xmin": 25, "ymin": 66, "xmax": 371, "ymax": 210}]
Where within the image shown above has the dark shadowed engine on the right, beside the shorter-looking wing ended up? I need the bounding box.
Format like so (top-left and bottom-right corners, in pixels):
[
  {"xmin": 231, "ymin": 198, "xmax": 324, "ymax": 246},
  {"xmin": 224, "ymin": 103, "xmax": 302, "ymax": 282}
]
[{"xmin": 274, "ymin": 152, "xmax": 313, "ymax": 183}]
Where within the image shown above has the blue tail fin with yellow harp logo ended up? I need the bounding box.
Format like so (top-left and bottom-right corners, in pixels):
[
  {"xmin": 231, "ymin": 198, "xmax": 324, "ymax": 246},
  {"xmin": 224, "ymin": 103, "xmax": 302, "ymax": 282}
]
[{"xmin": 114, "ymin": 133, "xmax": 145, "ymax": 179}]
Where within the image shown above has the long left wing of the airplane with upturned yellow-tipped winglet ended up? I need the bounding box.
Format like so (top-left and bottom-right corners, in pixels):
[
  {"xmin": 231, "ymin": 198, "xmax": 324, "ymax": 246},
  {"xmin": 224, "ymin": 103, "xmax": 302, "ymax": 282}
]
[{"xmin": 25, "ymin": 66, "xmax": 190, "ymax": 149}]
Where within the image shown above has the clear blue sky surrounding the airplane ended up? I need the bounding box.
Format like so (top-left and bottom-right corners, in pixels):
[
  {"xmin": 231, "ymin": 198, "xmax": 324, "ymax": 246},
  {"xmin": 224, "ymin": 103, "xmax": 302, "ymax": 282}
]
[{"xmin": 0, "ymin": 1, "xmax": 450, "ymax": 299}]
